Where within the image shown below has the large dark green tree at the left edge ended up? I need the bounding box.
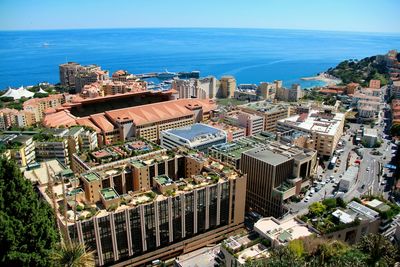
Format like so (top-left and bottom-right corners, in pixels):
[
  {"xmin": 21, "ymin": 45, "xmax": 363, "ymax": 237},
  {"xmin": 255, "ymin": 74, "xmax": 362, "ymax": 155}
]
[{"xmin": 0, "ymin": 157, "xmax": 59, "ymax": 266}]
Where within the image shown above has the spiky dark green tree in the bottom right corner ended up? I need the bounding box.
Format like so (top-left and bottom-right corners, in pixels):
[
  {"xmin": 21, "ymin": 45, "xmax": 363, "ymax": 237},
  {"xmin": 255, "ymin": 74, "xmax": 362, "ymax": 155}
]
[{"xmin": 357, "ymin": 234, "xmax": 397, "ymax": 266}]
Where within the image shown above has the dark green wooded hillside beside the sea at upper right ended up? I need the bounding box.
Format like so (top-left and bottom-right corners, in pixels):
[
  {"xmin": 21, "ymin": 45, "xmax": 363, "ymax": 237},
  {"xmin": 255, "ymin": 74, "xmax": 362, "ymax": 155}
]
[{"xmin": 327, "ymin": 56, "xmax": 389, "ymax": 87}]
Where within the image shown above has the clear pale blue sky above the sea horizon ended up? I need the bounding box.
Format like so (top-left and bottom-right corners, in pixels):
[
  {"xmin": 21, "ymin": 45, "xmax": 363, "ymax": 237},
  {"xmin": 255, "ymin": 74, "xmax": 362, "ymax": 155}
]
[{"xmin": 0, "ymin": 0, "xmax": 400, "ymax": 32}]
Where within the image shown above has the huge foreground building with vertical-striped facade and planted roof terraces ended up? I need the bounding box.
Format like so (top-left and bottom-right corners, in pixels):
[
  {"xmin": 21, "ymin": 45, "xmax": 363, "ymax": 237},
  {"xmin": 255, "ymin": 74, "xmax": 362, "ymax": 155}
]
[{"xmin": 45, "ymin": 150, "xmax": 246, "ymax": 266}]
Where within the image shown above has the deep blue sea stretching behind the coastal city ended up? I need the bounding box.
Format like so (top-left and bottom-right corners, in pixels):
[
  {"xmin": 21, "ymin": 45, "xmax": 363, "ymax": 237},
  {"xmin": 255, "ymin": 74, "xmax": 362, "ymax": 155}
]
[{"xmin": 0, "ymin": 28, "xmax": 400, "ymax": 89}]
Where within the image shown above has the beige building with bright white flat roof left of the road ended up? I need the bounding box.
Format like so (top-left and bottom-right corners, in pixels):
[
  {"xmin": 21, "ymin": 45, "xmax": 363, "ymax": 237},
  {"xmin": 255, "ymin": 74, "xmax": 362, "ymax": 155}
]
[{"xmin": 278, "ymin": 110, "xmax": 345, "ymax": 157}]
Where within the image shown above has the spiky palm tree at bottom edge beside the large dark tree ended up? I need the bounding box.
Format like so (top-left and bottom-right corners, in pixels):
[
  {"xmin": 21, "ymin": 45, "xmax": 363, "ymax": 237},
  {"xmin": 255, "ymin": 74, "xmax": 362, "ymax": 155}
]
[{"xmin": 51, "ymin": 242, "xmax": 95, "ymax": 267}]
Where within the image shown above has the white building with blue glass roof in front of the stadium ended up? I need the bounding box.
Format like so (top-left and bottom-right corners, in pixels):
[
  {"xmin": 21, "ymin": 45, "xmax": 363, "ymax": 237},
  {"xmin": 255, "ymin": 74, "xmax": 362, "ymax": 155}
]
[{"xmin": 161, "ymin": 123, "xmax": 227, "ymax": 152}]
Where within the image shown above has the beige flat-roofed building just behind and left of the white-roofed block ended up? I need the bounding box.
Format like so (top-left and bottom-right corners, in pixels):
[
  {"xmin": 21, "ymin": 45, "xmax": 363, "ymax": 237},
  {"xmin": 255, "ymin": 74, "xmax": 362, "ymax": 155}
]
[{"xmin": 238, "ymin": 101, "xmax": 291, "ymax": 132}]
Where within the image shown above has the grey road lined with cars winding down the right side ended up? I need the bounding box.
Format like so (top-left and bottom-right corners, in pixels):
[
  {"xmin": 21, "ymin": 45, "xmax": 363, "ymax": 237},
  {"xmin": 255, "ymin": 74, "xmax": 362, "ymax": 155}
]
[{"xmin": 287, "ymin": 86, "xmax": 397, "ymax": 215}]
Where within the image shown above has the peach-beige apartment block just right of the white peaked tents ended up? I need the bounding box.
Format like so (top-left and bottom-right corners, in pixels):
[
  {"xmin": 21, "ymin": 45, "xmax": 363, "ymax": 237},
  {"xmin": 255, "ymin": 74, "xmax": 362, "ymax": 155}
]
[{"xmin": 23, "ymin": 94, "xmax": 65, "ymax": 122}]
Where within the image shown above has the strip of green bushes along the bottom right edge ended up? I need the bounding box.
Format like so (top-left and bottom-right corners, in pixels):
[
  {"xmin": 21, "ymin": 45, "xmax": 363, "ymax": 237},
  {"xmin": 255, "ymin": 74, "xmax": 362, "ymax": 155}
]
[{"xmin": 245, "ymin": 237, "xmax": 400, "ymax": 267}]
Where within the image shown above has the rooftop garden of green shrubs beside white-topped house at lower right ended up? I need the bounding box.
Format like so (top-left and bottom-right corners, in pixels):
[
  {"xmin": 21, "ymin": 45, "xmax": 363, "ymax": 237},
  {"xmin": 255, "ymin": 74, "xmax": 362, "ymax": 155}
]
[{"xmin": 300, "ymin": 198, "xmax": 360, "ymax": 234}]
